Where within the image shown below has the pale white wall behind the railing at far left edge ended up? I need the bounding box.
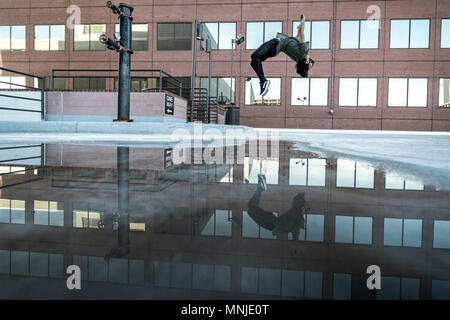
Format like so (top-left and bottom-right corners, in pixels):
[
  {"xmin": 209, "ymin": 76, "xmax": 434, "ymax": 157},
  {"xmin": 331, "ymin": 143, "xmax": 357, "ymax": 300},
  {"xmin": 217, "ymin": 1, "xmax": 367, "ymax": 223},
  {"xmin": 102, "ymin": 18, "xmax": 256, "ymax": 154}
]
[{"xmin": 0, "ymin": 90, "xmax": 41, "ymax": 121}]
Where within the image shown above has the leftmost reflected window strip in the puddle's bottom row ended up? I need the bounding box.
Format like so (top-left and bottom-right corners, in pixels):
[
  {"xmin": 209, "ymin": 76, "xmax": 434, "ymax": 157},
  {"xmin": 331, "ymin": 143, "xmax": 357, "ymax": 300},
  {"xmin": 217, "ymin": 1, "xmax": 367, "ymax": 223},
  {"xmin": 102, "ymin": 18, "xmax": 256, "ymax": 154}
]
[{"xmin": 0, "ymin": 250, "xmax": 64, "ymax": 278}]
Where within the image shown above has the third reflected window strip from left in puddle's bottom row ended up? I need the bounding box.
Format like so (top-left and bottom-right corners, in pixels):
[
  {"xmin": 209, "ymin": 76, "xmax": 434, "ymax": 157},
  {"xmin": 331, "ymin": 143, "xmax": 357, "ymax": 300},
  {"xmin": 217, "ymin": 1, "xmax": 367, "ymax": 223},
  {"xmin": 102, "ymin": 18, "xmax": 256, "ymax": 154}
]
[{"xmin": 153, "ymin": 261, "xmax": 231, "ymax": 291}]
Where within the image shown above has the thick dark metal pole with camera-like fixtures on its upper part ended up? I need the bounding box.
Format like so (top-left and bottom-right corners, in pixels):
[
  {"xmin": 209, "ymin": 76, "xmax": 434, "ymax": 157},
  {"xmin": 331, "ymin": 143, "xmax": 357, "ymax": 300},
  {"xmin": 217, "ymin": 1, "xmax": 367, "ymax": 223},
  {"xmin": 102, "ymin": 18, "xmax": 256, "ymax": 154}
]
[{"xmin": 100, "ymin": 1, "xmax": 134, "ymax": 122}]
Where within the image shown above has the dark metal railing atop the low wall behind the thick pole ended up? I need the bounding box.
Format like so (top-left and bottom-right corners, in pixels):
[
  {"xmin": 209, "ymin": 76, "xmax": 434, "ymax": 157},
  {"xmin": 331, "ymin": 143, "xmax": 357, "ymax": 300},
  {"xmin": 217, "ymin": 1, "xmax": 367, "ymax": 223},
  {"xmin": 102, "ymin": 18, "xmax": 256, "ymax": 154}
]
[{"xmin": 51, "ymin": 69, "xmax": 183, "ymax": 96}]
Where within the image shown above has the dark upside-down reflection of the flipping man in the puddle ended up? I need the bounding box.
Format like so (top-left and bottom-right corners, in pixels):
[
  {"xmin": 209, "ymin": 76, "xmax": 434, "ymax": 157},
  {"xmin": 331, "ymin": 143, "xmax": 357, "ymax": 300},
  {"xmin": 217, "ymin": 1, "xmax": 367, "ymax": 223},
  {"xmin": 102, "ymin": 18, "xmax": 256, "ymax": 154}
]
[{"xmin": 248, "ymin": 174, "xmax": 308, "ymax": 239}]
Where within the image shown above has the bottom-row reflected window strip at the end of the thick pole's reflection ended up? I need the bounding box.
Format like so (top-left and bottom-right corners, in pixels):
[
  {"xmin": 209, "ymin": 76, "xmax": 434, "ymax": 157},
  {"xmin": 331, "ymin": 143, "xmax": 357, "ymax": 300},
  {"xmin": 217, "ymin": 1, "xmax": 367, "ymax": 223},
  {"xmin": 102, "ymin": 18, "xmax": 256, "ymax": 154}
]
[{"xmin": 72, "ymin": 255, "xmax": 144, "ymax": 285}]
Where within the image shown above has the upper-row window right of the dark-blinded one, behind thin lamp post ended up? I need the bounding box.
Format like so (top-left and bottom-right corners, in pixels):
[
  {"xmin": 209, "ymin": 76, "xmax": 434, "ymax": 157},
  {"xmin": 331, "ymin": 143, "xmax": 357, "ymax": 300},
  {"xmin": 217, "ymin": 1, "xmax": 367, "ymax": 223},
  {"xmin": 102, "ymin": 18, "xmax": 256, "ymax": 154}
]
[{"xmin": 202, "ymin": 22, "xmax": 236, "ymax": 50}]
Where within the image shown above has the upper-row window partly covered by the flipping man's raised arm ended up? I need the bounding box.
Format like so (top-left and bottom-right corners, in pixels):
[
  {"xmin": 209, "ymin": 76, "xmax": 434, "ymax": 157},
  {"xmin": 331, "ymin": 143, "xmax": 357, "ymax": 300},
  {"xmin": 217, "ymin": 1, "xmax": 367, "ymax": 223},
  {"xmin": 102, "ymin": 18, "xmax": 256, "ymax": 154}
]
[{"xmin": 292, "ymin": 21, "xmax": 330, "ymax": 49}]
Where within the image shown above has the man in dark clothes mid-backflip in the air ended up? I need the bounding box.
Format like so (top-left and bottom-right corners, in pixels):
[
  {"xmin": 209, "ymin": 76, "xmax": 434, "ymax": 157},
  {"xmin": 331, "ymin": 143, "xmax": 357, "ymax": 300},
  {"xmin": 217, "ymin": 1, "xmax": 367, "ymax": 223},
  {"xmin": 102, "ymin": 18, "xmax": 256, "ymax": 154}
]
[{"xmin": 251, "ymin": 15, "xmax": 314, "ymax": 96}]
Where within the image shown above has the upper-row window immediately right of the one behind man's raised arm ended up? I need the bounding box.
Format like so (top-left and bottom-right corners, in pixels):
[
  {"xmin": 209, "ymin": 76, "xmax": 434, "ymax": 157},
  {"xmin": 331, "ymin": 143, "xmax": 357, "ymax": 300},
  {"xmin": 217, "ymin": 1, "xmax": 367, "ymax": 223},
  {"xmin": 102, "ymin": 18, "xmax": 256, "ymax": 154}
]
[{"xmin": 341, "ymin": 20, "xmax": 380, "ymax": 49}]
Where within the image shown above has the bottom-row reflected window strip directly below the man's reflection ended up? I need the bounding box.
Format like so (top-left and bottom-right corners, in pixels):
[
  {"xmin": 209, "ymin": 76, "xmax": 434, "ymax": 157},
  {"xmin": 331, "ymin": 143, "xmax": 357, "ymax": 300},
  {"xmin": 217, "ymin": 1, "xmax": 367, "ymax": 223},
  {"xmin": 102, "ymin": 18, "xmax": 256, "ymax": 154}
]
[{"xmin": 241, "ymin": 267, "xmax": 322, "ymax": 298}]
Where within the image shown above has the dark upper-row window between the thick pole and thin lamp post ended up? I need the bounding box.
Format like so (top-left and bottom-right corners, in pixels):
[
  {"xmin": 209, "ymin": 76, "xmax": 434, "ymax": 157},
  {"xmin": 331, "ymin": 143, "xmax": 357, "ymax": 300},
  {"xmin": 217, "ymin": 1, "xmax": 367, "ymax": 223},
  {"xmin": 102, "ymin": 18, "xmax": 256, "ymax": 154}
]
[{"xmin": 157, "ymin": 22, "xmax": 192, "ymax": 50}]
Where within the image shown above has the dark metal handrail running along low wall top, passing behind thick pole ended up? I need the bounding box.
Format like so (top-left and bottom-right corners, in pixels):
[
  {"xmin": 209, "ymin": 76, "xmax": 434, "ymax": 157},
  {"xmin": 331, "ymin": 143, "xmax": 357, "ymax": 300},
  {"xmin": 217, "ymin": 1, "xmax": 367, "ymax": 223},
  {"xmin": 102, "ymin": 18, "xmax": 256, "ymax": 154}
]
[{"xmin": 50, "ymin": 69, "xmax": 183, "ymax": 96}]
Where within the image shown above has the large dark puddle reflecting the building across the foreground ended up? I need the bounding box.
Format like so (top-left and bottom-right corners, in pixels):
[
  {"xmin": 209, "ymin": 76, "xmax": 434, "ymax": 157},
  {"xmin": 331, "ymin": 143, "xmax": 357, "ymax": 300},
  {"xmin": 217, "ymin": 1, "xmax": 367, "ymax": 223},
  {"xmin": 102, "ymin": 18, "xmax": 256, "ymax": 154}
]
[{"xmin": 0, "ymin": 142, "xmax": 450, "ymax": 299}]
